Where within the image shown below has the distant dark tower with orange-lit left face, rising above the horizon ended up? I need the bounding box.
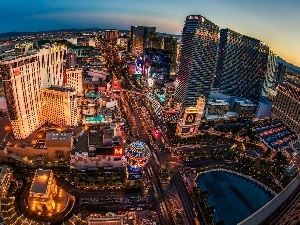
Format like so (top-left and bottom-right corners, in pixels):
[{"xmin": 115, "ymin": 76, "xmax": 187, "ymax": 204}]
[{"xmin": 130, "ymin": 26, "xmax": 156, "ymax": 56}]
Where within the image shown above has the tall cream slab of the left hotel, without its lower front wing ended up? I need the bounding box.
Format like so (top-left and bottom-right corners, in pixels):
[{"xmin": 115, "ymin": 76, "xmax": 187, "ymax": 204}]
[{"xmin": 0, "ymin": 45, "xmax": 66, "ymax": 139}]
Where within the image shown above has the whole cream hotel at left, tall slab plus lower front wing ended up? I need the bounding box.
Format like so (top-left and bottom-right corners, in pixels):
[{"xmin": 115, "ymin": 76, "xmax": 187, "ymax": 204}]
[{"xmin": 0, "ymin": 45, "xmax": 77, "ymax": 139}]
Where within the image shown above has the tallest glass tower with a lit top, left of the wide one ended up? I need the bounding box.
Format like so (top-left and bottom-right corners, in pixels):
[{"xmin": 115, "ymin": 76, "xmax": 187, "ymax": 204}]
[{"xmin": 174, "ymin": 15, "xmax": 219, "ymax": 107}]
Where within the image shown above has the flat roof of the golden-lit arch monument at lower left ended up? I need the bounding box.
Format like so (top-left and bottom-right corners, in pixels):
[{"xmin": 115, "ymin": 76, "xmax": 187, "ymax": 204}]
[{"xmin": 30, "ymin": 170, "xmax": 51, "ymax": 194}]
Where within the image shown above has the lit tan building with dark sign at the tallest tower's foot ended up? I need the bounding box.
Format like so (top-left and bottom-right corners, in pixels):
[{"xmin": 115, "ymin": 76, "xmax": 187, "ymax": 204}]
[{"xmin": 176, "ymin": 96, "xmax": 205, "ymax": 137}]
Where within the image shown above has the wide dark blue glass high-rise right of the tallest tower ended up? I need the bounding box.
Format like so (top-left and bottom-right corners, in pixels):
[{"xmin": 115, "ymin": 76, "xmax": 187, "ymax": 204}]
[{"xmin": 214, "ymin": 29, "xmax": 276, "ymax": 101}]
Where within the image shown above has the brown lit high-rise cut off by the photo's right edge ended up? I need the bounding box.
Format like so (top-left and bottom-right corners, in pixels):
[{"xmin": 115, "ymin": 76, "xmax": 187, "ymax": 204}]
[{"xmin": 271, "ymin": 76, "xmax": 300, "ymax": 134}]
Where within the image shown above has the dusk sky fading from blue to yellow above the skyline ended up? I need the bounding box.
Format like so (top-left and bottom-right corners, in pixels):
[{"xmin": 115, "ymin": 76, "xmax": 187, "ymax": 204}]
[{"xmin": 0, "ymin": 0, "xmax": 300, "ymax": 66}]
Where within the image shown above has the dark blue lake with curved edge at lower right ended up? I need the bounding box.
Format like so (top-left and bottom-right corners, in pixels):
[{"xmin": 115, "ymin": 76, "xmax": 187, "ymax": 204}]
[{"xmin": 197, "ymin": 171, "xmax": 274, "ymax": 225}]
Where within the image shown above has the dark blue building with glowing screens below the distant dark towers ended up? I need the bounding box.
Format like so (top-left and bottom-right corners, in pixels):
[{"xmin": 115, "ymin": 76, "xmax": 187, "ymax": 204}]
[{"xmin": 145, "ymin": 48, "xmax": 171, "ymax": 83}]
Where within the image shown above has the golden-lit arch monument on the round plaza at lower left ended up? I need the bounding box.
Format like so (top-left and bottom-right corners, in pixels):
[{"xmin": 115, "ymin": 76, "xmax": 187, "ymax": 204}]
[{"xmin": 28, "ymin": 169, "xmax": 57, "ymax": 211}]
